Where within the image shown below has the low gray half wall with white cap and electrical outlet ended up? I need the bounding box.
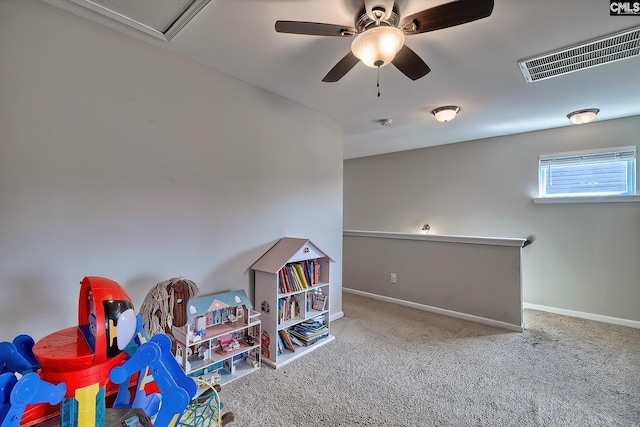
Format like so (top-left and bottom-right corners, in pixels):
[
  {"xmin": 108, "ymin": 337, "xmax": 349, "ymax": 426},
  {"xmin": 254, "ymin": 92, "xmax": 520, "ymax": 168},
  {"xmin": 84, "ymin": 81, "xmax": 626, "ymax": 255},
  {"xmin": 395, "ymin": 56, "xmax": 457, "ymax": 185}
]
[{"xmin": 342, "ymin": 234, "xmax": 524, "ymax": 331}]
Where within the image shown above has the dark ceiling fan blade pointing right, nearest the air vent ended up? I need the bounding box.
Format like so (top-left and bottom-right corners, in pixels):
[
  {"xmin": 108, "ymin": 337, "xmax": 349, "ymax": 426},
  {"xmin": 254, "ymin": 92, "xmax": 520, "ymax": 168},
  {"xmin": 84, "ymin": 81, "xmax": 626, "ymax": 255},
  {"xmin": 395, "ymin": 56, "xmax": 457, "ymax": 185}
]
[{"xmin": 399, "ymin": 0, "xmax": 493, "ymax": 35}]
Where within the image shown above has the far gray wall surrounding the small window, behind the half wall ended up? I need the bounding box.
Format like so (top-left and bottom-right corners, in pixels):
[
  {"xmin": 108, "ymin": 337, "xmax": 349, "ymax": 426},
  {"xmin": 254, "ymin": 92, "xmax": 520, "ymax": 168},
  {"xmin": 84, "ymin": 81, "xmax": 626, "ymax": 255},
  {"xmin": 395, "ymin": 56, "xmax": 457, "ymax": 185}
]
[{"xmin": 344, "ymin": 116, "xmax": 640, "ymax": 321}]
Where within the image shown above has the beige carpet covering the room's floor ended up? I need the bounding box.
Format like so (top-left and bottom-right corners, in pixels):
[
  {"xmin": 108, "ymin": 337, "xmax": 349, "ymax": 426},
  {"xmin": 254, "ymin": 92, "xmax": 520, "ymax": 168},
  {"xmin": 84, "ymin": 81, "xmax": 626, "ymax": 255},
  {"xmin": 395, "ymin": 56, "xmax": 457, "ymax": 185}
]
[{"xmin": 221, "ymin": 293, "xmax": 640, "ymax": 427}]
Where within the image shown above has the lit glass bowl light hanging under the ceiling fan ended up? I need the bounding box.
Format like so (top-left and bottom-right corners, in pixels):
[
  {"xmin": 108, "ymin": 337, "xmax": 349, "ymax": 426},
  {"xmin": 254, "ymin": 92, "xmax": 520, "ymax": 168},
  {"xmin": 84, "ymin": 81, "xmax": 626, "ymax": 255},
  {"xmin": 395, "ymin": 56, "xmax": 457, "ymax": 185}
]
[{"xmin": 351, "ymin": 26, "xmax": 404, "ymax": 68}]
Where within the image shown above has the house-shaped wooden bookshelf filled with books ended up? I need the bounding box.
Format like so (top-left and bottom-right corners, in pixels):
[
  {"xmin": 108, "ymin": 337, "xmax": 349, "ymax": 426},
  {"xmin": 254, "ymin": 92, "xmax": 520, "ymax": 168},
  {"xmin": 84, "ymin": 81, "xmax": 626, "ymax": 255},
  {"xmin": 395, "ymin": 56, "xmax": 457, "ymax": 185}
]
[{"xmin": 251, "ymin": 237, "xmax": 334, "ymax": 368}]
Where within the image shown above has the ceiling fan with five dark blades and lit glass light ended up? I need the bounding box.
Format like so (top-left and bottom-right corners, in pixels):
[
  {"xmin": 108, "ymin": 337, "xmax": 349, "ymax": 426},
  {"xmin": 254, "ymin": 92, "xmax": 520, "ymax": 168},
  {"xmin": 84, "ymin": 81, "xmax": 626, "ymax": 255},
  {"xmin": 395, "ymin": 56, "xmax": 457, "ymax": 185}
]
[{"xmin": 276, "ymin": 0, "xmax": 494, "ymax": 82}]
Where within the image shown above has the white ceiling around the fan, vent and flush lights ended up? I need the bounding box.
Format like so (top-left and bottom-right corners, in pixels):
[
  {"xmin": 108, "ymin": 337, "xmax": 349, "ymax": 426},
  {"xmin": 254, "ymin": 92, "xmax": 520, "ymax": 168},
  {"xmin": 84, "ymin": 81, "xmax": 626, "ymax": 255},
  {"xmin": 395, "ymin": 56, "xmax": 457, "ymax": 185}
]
[{"xmin": 44, "ymin": 0, "xmax": 640, "ymax": 159}]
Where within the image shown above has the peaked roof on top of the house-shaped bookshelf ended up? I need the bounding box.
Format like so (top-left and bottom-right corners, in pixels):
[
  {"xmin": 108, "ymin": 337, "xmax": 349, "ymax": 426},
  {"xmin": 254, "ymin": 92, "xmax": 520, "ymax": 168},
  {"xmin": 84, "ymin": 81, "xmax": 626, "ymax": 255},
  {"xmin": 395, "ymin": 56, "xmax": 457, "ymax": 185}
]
[{"xmin": 251, "ymin": 237, "xmax": 333, "ymax": 273}]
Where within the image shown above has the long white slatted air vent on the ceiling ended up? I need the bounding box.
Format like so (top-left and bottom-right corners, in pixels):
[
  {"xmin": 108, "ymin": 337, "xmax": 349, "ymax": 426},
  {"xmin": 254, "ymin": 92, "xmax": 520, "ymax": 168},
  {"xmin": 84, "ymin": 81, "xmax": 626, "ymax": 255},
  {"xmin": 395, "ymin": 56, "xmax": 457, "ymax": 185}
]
[{"xmin": 518, "ymin": 27, "xmax": 640, "ymax": 83}]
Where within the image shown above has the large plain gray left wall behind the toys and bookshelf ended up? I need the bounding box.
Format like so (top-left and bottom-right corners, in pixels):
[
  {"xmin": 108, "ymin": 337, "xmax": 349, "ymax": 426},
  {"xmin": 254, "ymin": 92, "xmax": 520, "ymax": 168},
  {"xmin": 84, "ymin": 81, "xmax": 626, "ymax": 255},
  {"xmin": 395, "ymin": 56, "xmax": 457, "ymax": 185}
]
[{"xmin": 0, "ymin": 0, "xmax": 343, "ymax": 340}]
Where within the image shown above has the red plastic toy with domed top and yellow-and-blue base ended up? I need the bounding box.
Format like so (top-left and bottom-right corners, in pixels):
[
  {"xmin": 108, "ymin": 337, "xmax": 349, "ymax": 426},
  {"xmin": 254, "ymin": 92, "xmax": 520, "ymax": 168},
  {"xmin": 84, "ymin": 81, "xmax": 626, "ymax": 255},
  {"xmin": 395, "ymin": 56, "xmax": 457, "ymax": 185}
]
[{"xmin": 33, "ymin": 277, "xmax": 136, "ymax": 427}]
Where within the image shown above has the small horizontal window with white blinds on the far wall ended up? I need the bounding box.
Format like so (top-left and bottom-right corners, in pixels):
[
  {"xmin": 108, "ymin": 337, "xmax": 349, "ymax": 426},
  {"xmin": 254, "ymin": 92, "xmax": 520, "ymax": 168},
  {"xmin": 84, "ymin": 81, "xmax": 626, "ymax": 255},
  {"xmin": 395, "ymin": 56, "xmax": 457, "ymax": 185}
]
[{"xmin": 538, "ymin": 146, "xmax": 637, "ymax": 198}]
